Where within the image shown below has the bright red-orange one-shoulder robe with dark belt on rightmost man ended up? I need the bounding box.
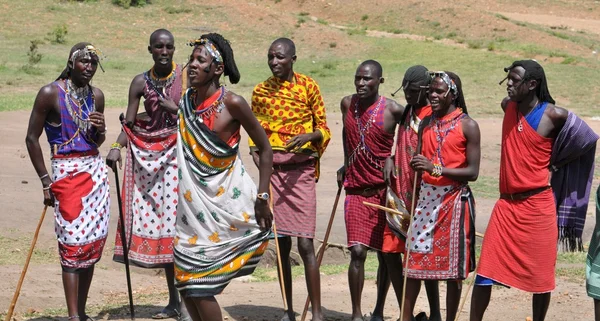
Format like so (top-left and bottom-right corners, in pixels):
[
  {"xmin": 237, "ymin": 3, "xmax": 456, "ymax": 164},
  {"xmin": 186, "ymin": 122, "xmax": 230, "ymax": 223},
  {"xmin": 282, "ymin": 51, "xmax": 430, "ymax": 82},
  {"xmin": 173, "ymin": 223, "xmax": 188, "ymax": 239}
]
[{"xmin": 478, "ymin": 102, "xmax": 558, "ymax": 293}]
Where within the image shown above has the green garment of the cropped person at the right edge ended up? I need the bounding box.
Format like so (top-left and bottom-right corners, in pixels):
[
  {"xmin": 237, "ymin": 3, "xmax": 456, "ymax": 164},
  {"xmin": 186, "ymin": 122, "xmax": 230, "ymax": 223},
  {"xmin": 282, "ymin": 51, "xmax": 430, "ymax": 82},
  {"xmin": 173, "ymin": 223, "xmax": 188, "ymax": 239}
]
[{"xmin": 585, "ymin": 187, "xmax": 600, "ymax": 300}]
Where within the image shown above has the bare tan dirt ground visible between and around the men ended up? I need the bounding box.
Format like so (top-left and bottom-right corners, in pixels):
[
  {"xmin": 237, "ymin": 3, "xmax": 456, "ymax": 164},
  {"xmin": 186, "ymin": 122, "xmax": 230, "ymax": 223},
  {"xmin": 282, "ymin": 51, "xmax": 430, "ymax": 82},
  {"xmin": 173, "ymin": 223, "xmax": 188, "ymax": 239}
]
[{"xmin": 0, "ymin": 109, "xmax": 600, "ymax": 320}]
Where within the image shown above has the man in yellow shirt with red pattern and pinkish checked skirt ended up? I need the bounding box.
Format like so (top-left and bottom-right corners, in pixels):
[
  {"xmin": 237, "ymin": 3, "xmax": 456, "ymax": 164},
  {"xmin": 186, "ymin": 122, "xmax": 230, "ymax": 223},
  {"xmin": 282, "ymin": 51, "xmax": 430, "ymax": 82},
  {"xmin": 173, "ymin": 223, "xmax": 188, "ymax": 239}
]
[{"xmin": 250, "ymin": 38, "xmax": 331, "ymax": 321}]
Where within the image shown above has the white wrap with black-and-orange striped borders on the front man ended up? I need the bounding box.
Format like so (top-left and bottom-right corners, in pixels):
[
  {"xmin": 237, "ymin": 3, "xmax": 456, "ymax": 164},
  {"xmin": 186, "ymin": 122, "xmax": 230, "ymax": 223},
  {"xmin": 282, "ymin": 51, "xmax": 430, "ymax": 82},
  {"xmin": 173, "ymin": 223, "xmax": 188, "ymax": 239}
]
[{"xmin": 174, "ymin": 89, "xmax": 269, "ymax": 297}]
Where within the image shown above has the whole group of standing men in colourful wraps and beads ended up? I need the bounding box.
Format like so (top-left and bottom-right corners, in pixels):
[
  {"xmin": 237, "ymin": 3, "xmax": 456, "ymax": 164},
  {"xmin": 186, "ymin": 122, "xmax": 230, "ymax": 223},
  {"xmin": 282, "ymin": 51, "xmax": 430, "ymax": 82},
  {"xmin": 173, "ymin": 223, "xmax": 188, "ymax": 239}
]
[{"xmin": 26, "ymin": 29, "xmax": 600, "ymax": 321}]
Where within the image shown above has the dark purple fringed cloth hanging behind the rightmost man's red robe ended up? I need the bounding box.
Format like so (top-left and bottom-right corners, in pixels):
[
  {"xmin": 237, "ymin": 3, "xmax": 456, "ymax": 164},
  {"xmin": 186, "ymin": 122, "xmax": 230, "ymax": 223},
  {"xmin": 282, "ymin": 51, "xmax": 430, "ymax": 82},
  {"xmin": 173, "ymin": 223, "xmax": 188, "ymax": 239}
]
[{"xmin": 550, "ymin": 112, "xmax": 598, "ymax": 251}]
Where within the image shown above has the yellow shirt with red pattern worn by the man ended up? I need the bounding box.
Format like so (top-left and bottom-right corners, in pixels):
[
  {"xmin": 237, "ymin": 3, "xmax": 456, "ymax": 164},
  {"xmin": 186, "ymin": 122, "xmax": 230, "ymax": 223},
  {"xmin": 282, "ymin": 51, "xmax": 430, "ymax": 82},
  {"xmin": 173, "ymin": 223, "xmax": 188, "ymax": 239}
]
[{"xmin": 248, "ymin": 73, "xmax": 331, "ymax": 179}]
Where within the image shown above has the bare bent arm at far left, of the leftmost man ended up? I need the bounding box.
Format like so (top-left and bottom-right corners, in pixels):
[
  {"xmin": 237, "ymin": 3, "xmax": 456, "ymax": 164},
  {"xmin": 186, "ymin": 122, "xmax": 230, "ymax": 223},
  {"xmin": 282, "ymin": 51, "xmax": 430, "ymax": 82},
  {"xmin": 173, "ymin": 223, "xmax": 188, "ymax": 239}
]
[{"xmin": 25, "ymin": 84, "xmax": 58, "ymax": 206}]
